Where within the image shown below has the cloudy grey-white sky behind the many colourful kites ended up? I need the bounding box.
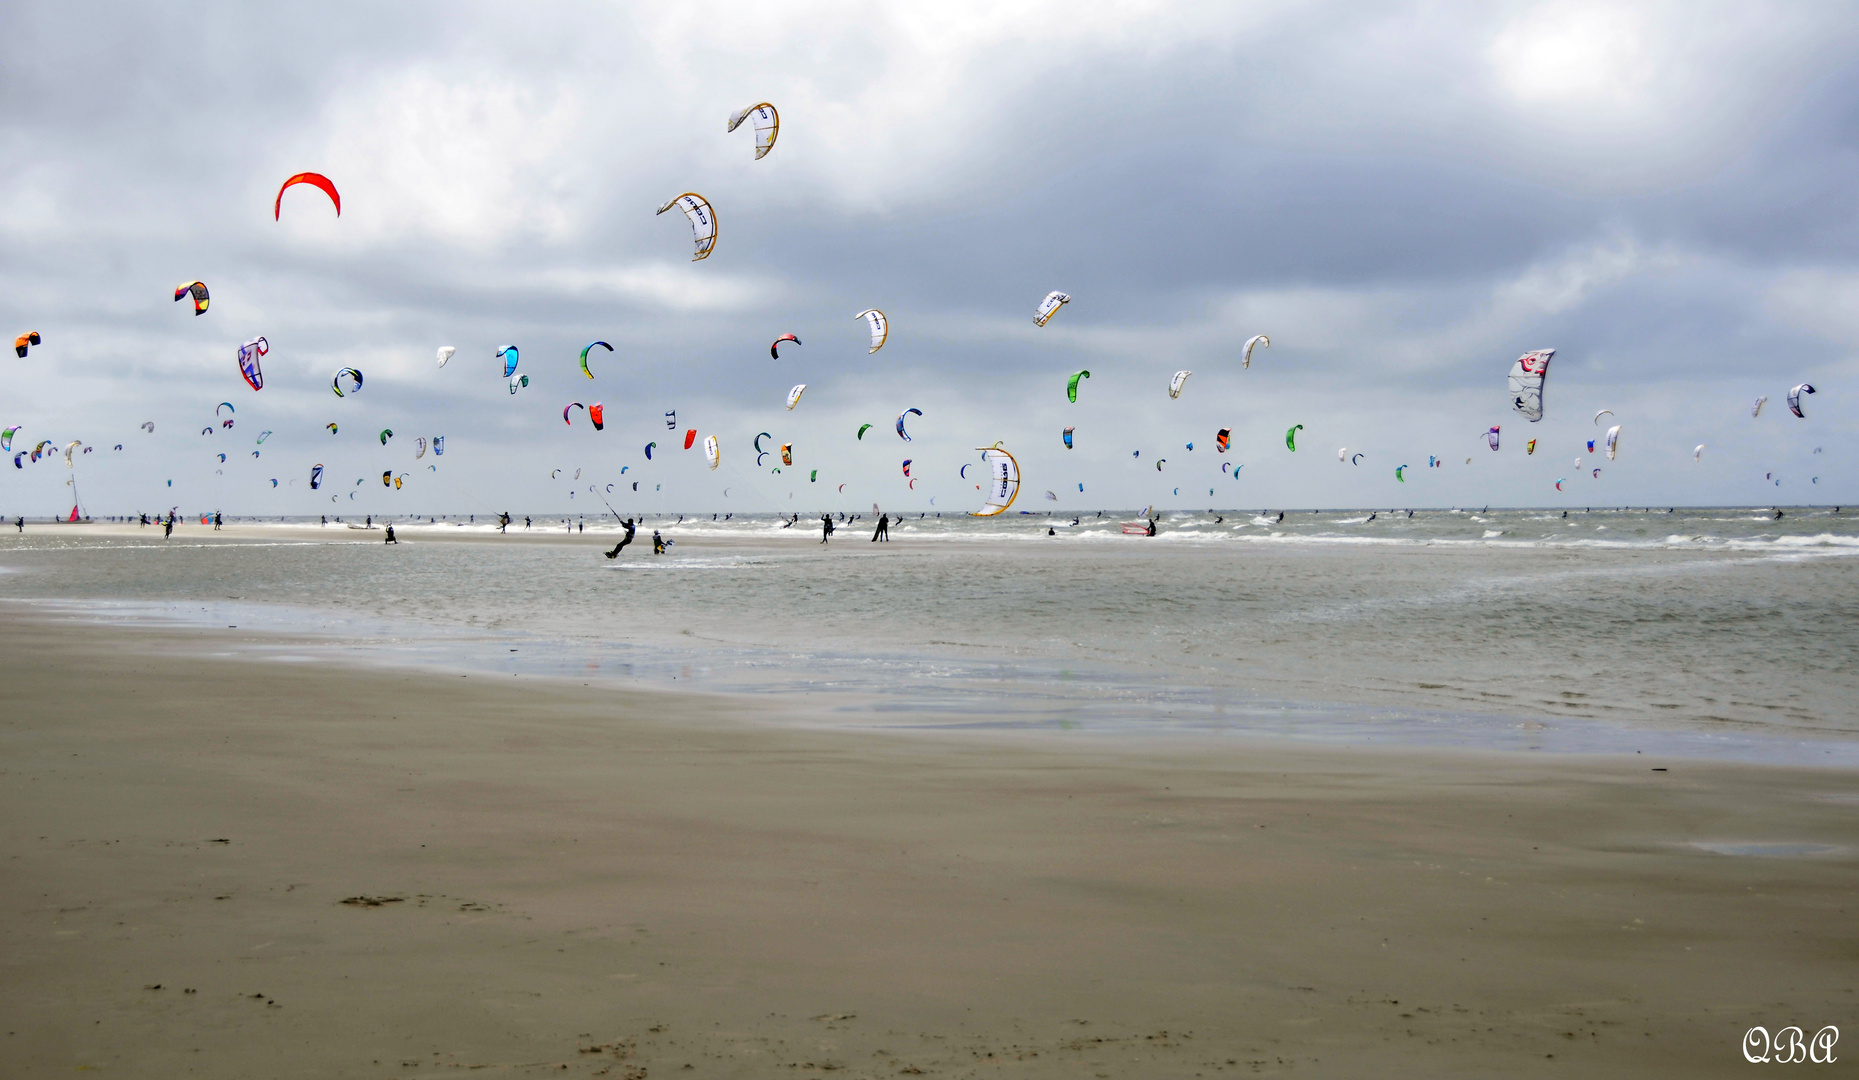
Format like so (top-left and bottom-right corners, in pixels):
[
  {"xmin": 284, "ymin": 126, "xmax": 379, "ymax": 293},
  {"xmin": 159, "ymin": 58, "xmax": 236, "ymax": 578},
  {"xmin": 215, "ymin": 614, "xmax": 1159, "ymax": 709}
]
[{"xmin": 0, "ymin": 0, "xmax": 1859, "ymax": 515}]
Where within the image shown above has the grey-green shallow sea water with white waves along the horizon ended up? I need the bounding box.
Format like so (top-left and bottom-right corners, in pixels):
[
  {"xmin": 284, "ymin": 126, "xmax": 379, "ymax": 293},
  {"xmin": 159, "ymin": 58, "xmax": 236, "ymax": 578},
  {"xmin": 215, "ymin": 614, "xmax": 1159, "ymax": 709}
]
[{"xmin": 0, "ymin": 507, "xmax": 1859, "ymax": 766}]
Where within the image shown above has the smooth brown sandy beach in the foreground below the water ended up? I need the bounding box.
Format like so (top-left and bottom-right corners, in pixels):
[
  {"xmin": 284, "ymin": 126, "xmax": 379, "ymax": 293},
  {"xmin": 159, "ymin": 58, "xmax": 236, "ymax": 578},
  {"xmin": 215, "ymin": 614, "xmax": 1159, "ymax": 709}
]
[{"xmin": 0, "ymin": 619, "xmax": 1859, "ymax": 1078}]
